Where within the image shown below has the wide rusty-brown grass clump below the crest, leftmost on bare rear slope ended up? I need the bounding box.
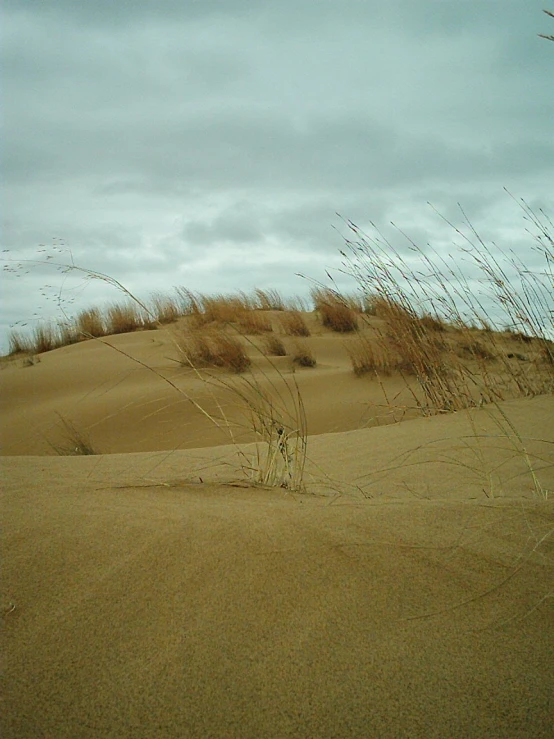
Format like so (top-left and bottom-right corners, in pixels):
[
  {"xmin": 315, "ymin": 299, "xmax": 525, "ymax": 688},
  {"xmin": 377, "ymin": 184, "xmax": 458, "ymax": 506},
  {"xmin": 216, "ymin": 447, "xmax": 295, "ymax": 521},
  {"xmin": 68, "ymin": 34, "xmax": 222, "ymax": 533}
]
[{"xmin": 178, "ymin": 330, "xmax": 251, "ymax": 373}]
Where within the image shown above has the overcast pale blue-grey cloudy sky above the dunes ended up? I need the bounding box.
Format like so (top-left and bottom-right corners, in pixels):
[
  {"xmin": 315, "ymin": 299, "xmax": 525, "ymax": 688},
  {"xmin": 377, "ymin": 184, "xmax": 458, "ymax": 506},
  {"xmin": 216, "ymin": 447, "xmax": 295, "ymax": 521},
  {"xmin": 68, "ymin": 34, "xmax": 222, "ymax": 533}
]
[{"xmin": 0, "ymin": 0, "xmax": 554, "ymax": 348}]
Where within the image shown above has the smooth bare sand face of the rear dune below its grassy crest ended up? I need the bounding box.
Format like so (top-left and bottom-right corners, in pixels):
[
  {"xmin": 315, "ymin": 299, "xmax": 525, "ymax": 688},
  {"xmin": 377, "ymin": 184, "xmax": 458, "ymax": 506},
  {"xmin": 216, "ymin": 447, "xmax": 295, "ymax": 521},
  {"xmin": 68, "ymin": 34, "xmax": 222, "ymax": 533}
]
[{"xmin": 0, "ymin": 317, "xmax": 420, "ymax": 454}]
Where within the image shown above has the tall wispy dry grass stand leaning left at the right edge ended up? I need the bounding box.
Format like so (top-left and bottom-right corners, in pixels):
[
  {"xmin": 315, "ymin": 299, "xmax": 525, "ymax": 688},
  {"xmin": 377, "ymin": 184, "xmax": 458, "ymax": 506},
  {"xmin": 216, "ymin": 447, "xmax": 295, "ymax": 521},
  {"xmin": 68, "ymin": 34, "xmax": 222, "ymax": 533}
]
[{"xmin": 343, "ymin": 199, "xmax": 554, "ymax": 413}]
